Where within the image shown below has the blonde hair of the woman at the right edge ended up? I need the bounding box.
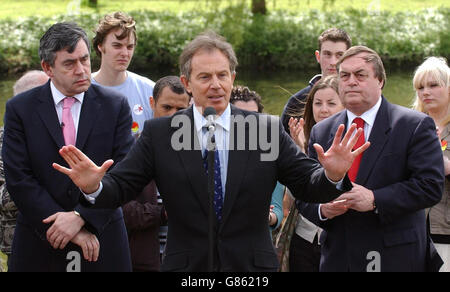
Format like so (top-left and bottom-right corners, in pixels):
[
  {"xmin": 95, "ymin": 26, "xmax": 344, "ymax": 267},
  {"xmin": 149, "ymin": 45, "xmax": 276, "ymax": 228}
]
[{"xmin": 413, "ymin": 57, "xmax": 450, "ymax": 124}]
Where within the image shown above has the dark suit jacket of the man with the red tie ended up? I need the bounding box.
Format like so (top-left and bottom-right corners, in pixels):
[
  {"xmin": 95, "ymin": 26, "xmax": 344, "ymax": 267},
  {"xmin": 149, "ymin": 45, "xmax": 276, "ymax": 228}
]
[{"xmin": 300, "ymin": 97, "xmax": 444, "ymax": 271}]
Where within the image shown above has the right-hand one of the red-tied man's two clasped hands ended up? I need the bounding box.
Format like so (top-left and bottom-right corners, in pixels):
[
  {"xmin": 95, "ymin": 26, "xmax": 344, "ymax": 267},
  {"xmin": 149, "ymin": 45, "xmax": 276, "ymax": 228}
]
[{"xmin": 338, "ymin": 183, "xmax": 375, "ymax": 212}]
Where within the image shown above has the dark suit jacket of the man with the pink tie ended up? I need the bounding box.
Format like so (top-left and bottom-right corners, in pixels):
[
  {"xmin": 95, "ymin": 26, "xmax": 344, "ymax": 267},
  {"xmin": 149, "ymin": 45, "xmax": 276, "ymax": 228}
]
[{"xmin": 2, "ymin": 82, "xmax": 133, "ymax": 271}]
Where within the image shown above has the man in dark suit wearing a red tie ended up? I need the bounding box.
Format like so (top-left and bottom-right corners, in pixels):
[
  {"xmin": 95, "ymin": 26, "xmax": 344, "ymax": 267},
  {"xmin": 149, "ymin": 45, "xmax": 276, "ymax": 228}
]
[{"xmin": 300, "ymin": 46, "xmax": 444, "ymax": 271}]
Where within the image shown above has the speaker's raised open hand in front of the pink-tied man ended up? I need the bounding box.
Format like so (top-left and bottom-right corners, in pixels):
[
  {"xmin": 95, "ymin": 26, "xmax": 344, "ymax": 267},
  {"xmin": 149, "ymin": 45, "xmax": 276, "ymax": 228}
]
[{"xmin": 52, "ymin": 145, "xmax": 114, "ymax": 194}]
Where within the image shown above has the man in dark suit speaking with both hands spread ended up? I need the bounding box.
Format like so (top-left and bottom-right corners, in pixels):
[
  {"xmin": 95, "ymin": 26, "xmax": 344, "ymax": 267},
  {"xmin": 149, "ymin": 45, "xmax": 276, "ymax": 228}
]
[{"xmin": 54, "ymin": 32, "xmax": 369, "ymax": 271}]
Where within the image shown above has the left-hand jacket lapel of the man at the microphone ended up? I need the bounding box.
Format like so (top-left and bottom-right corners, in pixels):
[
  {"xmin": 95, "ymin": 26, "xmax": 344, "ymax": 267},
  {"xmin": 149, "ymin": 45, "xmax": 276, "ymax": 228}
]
[{"xmin": 170, "ymin": 107, "xmax": 209, "ymax": 216}]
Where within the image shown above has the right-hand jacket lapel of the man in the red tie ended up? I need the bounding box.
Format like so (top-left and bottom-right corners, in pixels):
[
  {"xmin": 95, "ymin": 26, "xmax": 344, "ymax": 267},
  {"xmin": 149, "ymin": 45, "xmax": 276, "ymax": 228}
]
[{"xmin": 355, "ymin": 97, "xmax": 391, "ymax": 185}]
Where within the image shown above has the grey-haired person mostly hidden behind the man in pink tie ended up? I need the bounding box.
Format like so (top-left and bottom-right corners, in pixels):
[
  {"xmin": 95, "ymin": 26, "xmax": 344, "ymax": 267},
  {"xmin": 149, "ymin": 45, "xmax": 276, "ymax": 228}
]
[{"xmin": 0, "ymin": 70, "xmax": 48, "ymax": 266}]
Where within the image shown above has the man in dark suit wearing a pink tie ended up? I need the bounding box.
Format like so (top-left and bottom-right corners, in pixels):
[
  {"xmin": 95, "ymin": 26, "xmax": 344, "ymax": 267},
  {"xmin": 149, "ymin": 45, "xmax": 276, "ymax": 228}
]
[{"xmin": 2, "ymin": 23, "xmax": 133, "ymax": 271}]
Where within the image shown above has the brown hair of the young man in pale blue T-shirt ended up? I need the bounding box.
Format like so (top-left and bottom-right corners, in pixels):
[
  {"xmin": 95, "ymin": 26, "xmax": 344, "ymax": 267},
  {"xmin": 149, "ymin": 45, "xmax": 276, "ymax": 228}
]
[{"xmin": 92, "ymin": 12, "xmax": 137, "ymax": 58}]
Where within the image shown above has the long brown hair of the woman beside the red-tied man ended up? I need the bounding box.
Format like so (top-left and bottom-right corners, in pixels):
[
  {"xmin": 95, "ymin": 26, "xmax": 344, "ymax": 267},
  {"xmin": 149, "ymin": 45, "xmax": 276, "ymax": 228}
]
[{"xmin": 301, "ymin": 75, "xmax": 339, "ymax": 151}]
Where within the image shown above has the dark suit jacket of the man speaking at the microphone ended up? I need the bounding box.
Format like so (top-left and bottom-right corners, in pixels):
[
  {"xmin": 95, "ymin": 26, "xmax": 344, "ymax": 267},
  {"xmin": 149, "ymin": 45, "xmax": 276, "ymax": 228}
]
[{"xmin": 92, "ymin": 106, "xmax": 349, "ymax": 271}]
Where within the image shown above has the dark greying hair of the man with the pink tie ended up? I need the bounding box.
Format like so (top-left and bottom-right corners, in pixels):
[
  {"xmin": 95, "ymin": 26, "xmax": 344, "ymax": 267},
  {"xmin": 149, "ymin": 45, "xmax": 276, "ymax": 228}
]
[{"xmin": 39, "ymin": 22, "xmax": 90, "ymax": 66}]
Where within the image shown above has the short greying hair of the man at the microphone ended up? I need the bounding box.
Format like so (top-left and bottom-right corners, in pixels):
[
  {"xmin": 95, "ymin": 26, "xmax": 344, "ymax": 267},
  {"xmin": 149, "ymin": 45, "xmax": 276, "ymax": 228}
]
[{"xmin": 180, "ymin": 30, "xmax": 238, "ymax": 80}]
